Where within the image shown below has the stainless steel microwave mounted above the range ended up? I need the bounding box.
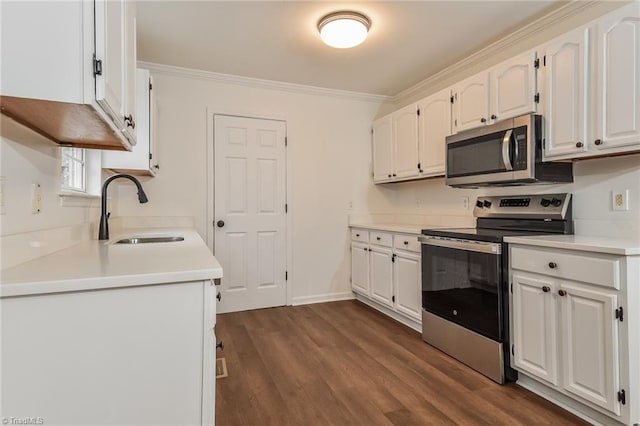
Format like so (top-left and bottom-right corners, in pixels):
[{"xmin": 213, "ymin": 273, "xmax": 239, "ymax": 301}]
[{"xmin": 445, "ymin": 114, "xmax": 573, "ymax": 188}]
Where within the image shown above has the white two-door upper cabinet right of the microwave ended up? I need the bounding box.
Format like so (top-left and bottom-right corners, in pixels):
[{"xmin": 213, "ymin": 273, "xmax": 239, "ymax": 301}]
[{"xmin": 541, "ymin": 2, "xmax": 640, "ymax": 160}]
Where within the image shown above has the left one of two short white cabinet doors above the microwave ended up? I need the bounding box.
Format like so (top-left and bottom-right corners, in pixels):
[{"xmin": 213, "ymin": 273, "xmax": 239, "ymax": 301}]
[{"xmin": 454, "ymin": 71, "xmax": 489, "ymax": 132}]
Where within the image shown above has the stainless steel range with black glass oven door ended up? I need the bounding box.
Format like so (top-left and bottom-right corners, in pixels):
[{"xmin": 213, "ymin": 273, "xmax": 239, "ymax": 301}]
[{"xmin": 419, "ymin": 194, "xmax": 573, "ymax": 383}]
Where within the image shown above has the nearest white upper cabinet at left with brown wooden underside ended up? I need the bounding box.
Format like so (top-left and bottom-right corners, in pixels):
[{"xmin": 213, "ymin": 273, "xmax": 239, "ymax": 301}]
[{"xmin": 0, "ymin": 0, "xmax": 136, "ymax": 150}]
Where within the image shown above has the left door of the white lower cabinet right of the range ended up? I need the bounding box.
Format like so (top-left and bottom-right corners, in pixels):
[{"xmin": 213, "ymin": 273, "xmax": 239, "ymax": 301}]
[{"xmin": 511, "ymin": 273, "xmax": 558, "ymax": 386}]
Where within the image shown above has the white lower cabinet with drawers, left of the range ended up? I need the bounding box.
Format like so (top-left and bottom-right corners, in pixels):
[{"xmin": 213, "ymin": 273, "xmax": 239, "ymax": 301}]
[{"xmin": 351, "ymin": 228, "xmax": 422, "ymax": 329}]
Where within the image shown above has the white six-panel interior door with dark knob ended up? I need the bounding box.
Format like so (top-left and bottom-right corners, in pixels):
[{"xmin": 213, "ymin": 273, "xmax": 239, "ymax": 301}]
[{"xmin": 213, "ymin": 115, "xmax": 286, "ymax": 313}]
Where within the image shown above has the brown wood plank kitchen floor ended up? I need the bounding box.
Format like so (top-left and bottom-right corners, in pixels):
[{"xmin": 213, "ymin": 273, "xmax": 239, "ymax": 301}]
[{"xmin": 216, "ymin": 301, "xmax": 587, "ymax": 426}]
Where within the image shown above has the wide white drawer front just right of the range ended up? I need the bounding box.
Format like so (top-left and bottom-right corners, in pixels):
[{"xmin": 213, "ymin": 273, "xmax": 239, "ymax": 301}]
[{"xmin": 511, "ymin": 246, "xmax": 620, "ymax": 289}]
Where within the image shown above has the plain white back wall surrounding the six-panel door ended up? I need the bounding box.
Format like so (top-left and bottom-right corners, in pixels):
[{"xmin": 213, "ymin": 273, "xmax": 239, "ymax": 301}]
[{"xmin": 113, "ymin": 72, "xmax": 392, "ymax": 303}]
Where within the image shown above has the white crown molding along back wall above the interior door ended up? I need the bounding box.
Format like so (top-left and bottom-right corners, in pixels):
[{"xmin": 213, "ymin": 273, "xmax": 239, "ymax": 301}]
[{"xmin": 137, "ymin": 61, "xmax": 391, "ymax": 102}]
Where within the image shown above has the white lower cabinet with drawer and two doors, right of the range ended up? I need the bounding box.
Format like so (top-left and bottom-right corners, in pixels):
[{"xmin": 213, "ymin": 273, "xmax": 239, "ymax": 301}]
[{"xmin": 510, "ymin": 245, "xmax": 640, "ymax": 424}]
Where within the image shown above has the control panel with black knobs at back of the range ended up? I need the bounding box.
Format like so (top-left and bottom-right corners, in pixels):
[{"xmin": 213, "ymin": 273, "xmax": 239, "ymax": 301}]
[{"xmin": 473, "ymin": 194, "xmax": 571, "ymax": 220}]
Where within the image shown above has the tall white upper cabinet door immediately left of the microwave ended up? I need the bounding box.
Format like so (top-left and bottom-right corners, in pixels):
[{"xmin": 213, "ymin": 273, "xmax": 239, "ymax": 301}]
[{"xmin": 418, "ymin": 89, "xmax": 452, "ymax": 176}]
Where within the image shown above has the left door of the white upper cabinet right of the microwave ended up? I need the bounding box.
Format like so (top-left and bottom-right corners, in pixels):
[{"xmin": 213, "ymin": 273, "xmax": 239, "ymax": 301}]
[{"xmin": 543, "ymin": 28, "xmax": 590, "ymax": 158}]
